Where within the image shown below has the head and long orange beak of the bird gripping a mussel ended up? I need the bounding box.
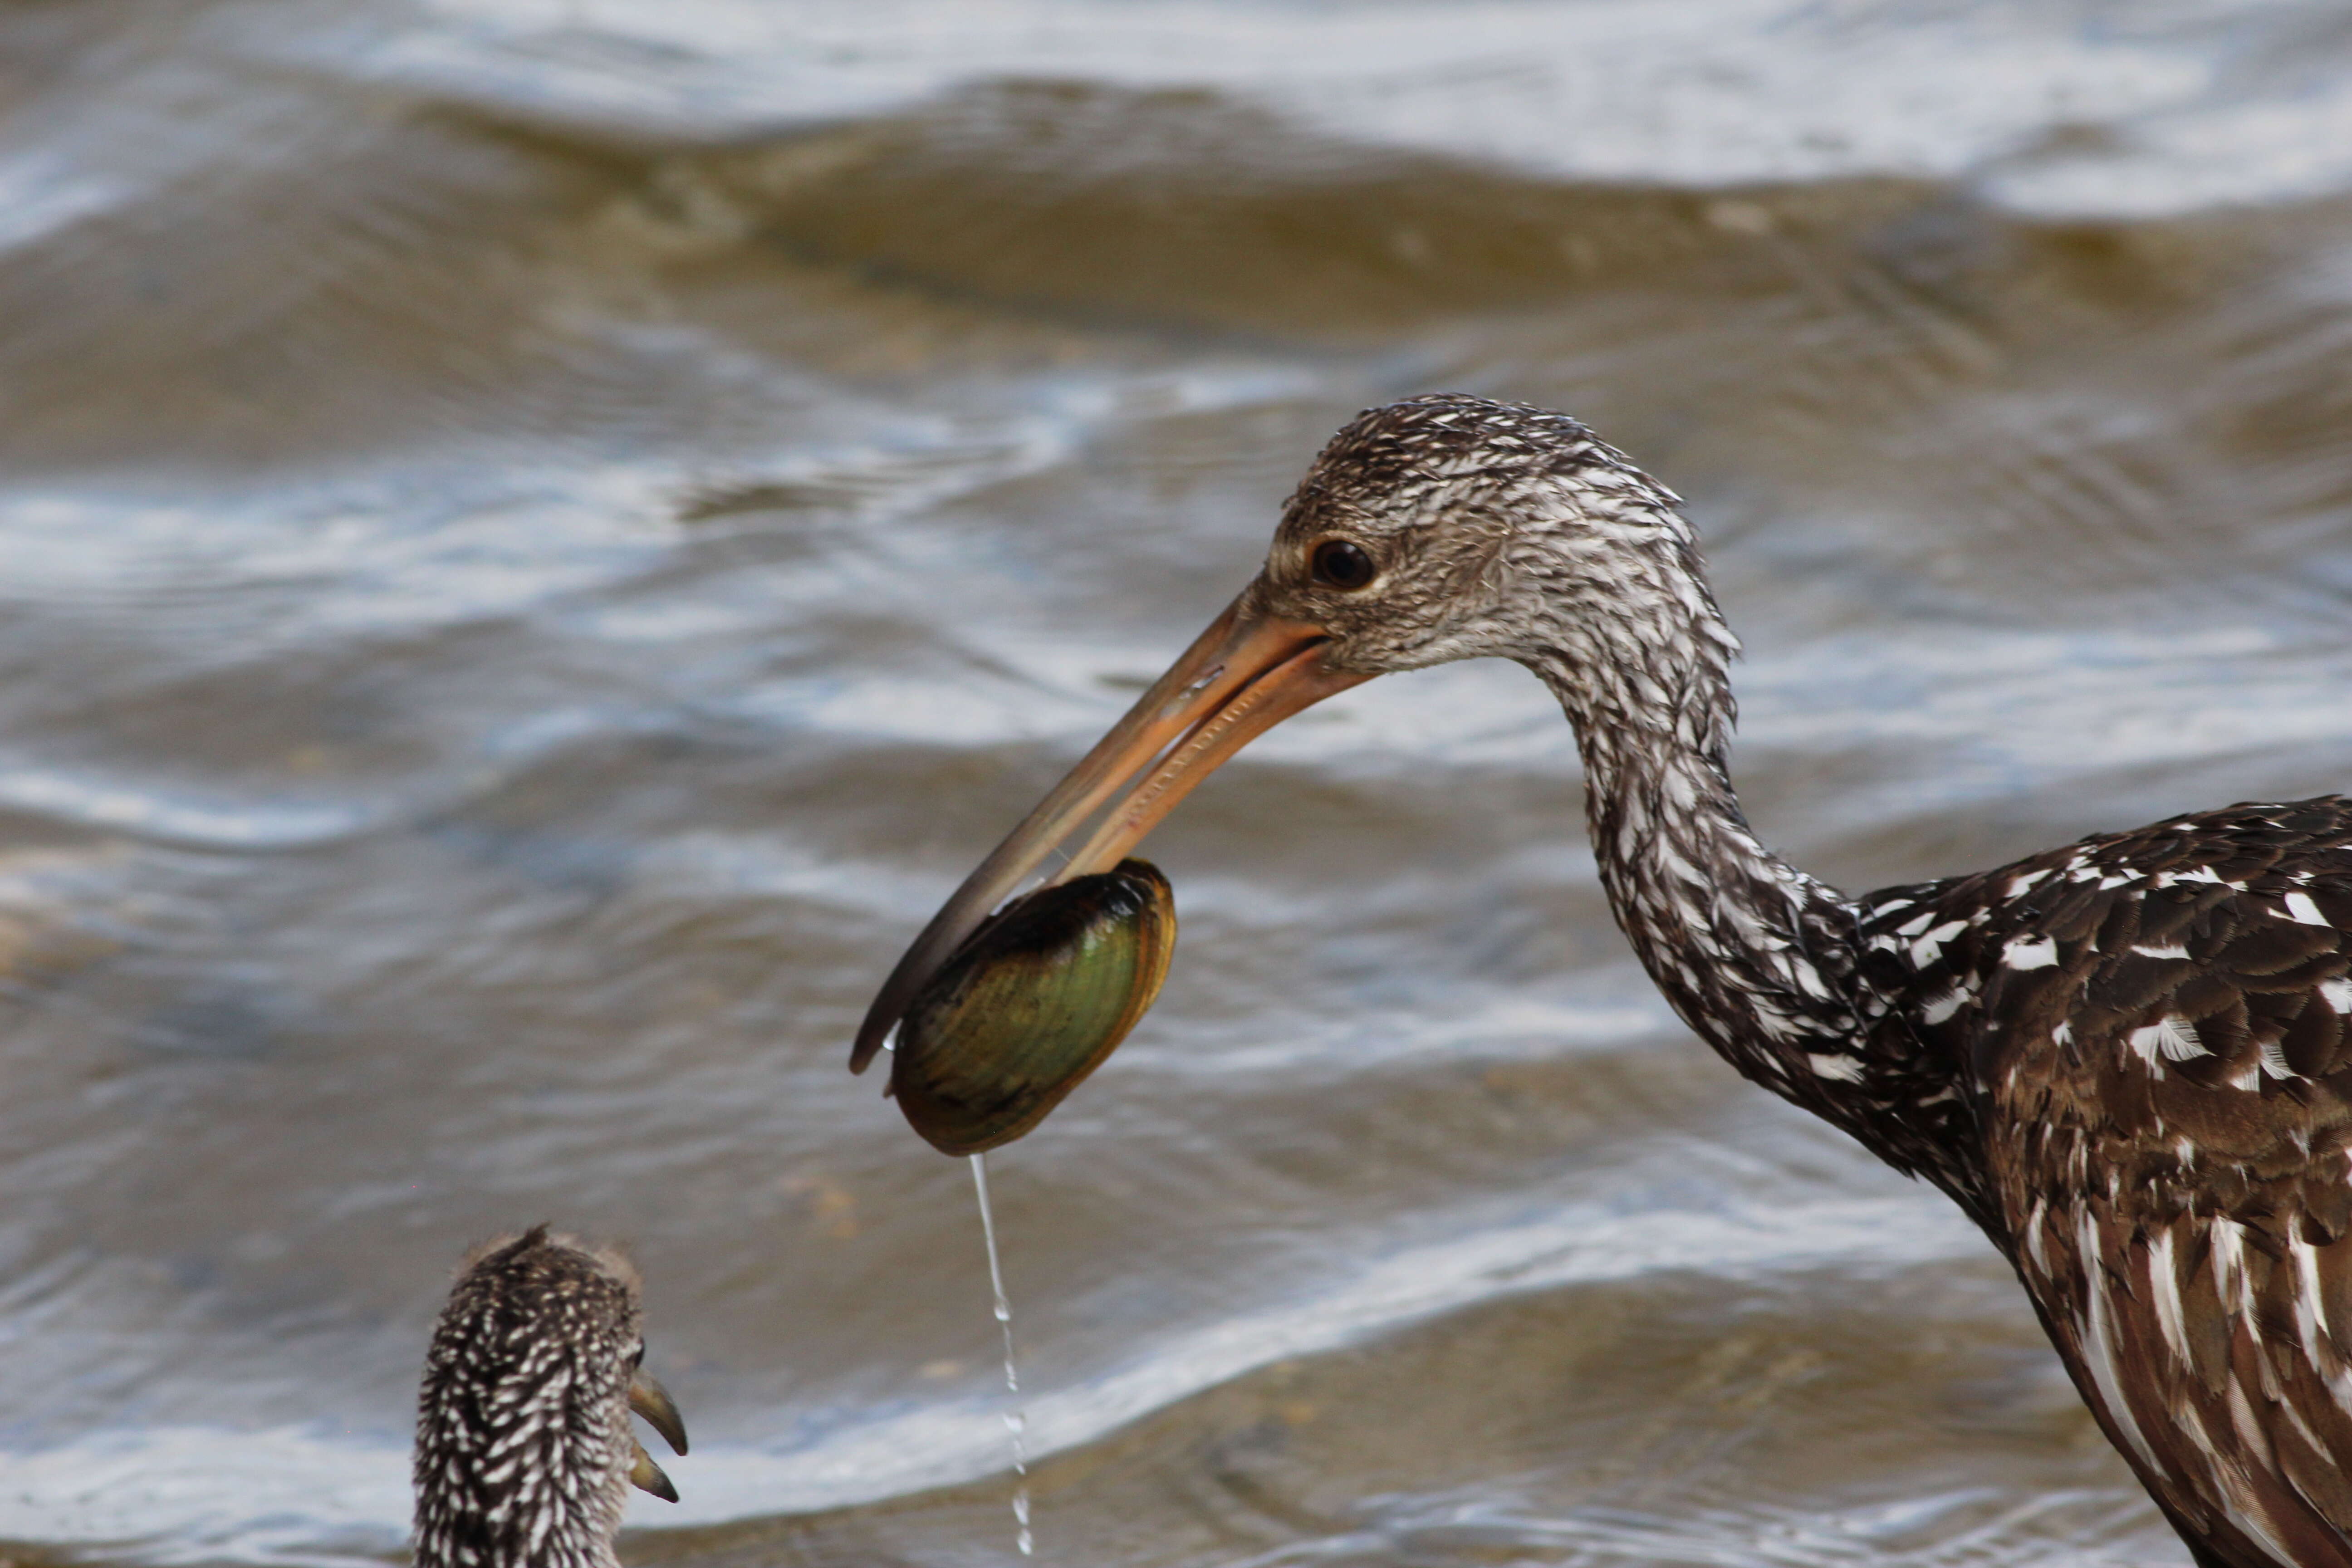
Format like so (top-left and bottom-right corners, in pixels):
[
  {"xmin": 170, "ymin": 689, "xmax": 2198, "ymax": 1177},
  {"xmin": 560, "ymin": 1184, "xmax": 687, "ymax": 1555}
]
[{"xmin": 849, "ymin": 395, "xmax": 1731, "ymax": 1070}]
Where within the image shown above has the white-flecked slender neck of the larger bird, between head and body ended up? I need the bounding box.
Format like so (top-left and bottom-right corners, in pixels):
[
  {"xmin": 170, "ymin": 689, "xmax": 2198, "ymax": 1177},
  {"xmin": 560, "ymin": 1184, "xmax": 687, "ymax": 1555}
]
[{"xmin": 1531, "ymin": 644, "xmax": 1861, "ymax": 1110}]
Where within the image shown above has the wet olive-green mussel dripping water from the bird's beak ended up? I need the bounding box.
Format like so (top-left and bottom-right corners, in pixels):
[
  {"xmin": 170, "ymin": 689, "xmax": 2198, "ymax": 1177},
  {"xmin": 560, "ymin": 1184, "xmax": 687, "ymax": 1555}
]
[{"xmin": 889, "ymin": 860, "xmax": 1176, "ymax": 1154}]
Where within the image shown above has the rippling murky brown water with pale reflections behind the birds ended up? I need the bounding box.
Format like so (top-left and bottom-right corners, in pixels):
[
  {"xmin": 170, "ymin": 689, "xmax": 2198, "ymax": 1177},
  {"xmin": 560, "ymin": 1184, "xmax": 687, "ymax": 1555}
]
[{"xmin": 0, "ymin": 0, "xmax": 2352, "ymax": 1568}]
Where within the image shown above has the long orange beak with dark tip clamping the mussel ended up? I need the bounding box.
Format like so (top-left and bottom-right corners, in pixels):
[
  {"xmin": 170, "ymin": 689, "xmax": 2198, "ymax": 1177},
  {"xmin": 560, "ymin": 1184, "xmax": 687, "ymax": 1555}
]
[{"xmin": 849, "ymin": 593, "xmax": 1371, "ymax": 1072}]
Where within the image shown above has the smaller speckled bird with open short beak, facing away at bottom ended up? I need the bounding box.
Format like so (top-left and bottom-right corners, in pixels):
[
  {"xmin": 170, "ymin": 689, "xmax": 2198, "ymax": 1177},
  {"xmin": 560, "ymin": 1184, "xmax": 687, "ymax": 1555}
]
[{"xmin": 414, "ymin": 1225, "xmax": 687, "ymax": 1568}]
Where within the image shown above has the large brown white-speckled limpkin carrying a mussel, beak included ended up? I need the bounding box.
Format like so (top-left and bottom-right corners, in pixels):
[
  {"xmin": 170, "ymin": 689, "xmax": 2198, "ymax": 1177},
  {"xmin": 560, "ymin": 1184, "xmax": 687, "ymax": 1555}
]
[{"xmin": 852, "ymin": 395, "xmax": 2352, "ymax": 1568}]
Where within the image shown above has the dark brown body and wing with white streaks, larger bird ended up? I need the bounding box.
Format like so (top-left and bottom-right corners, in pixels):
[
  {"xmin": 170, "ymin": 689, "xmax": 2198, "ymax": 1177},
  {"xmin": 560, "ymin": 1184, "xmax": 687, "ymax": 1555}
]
[{"xmin": 1865, "ymin": 799, "xmax": 2352, "ymax": 1568}]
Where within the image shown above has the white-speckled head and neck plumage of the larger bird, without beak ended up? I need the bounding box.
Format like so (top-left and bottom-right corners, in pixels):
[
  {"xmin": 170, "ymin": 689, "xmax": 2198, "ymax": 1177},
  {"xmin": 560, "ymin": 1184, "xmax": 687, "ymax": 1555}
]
[{"xmin": 1282, "ymin": 397, "xmax": 1966, "ymax": 1187}]
